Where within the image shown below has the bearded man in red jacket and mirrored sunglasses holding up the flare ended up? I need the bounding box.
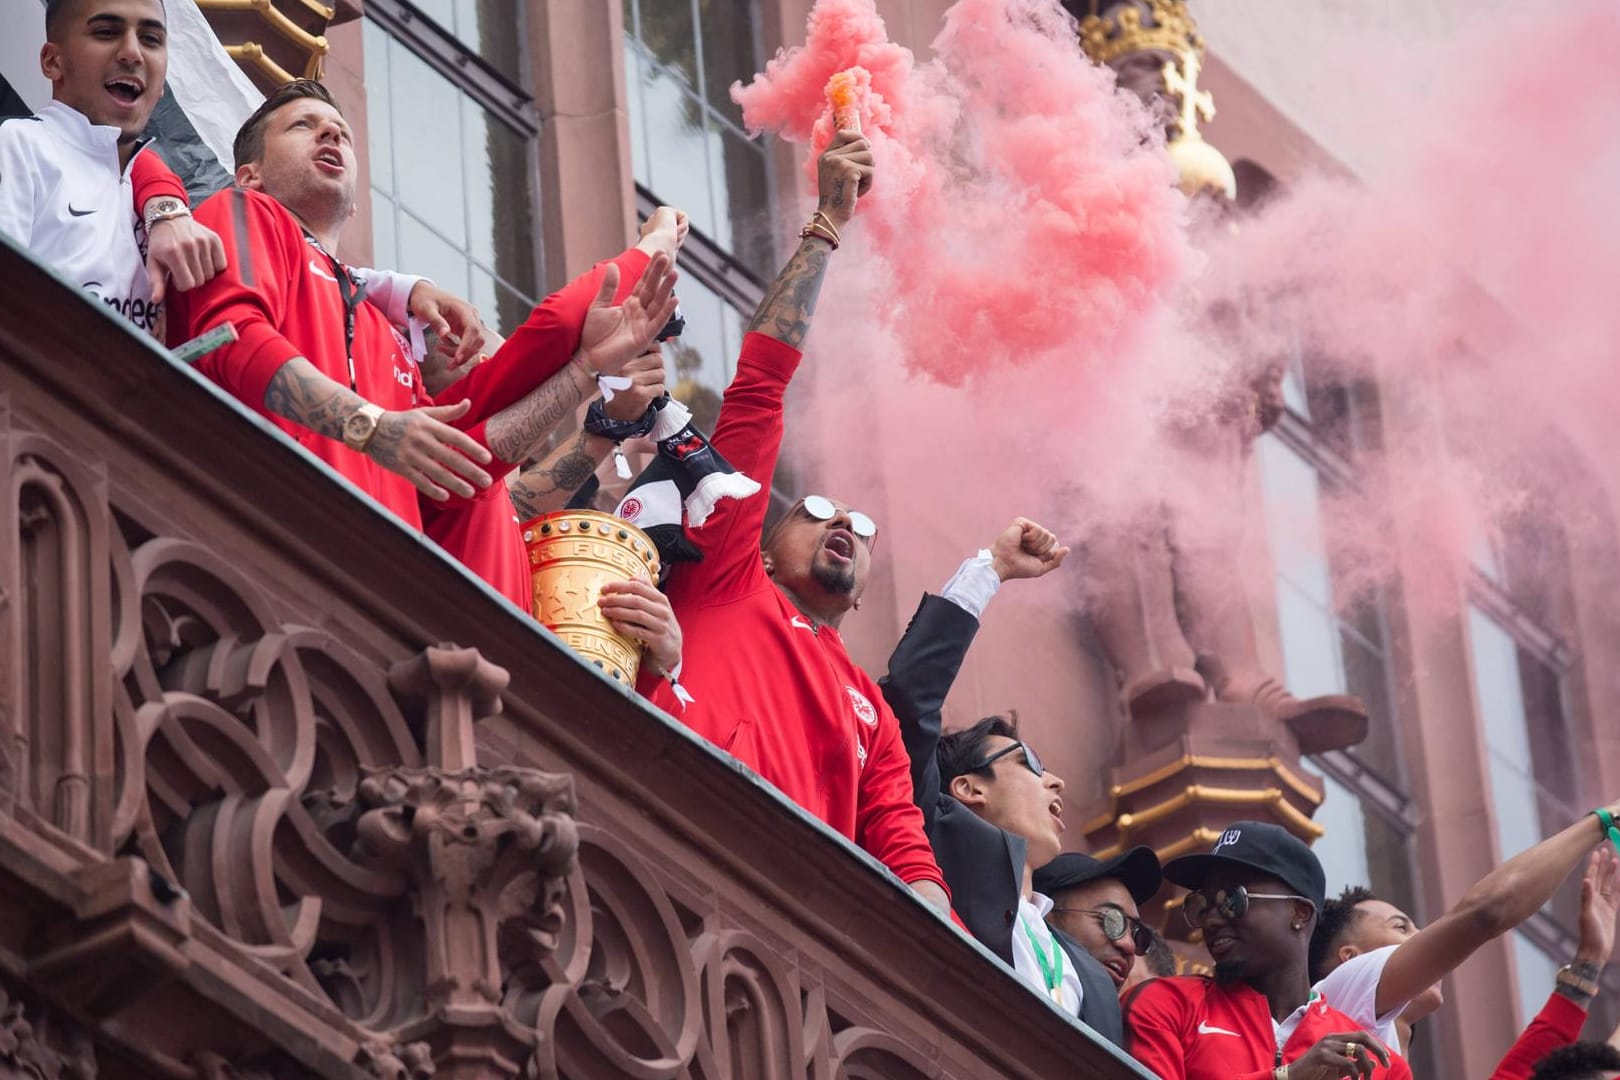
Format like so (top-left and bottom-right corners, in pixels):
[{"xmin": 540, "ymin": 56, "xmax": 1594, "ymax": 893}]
[{"xmin": 642, "ymin": 131, "xmax": 949, "ymax": 913}]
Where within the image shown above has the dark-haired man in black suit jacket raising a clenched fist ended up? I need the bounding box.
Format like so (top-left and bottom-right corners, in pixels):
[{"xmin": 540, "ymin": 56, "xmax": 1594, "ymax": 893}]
[{"xmin": 880, "ymin": 518, "xmax": 1124, "ymax": 1044}]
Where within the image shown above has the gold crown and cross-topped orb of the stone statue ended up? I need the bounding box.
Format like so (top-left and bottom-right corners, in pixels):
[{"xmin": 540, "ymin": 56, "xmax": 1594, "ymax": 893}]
[{"xmin": 1081, "ymin": 0, "xmax": 1238, "ymax": 199}]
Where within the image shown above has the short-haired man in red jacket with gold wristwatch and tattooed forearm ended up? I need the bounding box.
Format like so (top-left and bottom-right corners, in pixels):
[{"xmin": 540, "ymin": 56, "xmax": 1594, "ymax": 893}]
[{"xmin": 170, "ymin": 81, "xmax": 674, "ymax": 576}]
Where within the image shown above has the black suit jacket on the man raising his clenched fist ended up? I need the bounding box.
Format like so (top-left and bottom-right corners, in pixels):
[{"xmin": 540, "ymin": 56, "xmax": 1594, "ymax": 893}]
[{"xmin": 878, "ymin": 596, "xmax": 1124, "ymax": 1046}]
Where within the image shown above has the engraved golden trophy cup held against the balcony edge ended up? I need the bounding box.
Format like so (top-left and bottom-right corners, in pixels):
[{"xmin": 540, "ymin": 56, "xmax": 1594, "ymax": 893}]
[{"xmin": 518, "ymin": 510, "xmax": 658, "ymax": 687}]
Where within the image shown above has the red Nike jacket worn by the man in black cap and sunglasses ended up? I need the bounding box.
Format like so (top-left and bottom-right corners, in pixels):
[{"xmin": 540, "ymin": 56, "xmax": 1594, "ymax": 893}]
[{"xmin": 1124, "ymin": 975, "xmax": 1413, "ymax": 1080}]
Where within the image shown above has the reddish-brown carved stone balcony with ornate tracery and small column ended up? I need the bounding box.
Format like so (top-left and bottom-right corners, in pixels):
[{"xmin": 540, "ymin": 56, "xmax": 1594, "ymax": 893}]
[{"xmin": 0, "ymin": 240, "xmax": 1145, "ymax": 1080}]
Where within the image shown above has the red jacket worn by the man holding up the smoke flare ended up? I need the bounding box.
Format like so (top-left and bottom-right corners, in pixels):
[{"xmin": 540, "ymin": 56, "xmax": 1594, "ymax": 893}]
[{"xmin": 642, "ymin": 334, "xmax": 944, "ymax": 889}]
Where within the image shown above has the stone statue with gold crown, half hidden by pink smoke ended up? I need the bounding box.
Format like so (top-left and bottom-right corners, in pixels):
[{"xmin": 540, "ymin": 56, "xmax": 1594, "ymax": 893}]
[{"xmin": 1077, "ymin": 0, "xmax": 1367, "ymax": 753}]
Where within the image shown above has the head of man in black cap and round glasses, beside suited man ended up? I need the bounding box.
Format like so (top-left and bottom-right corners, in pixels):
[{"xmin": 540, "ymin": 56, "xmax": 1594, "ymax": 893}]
[{"xmin": 1034, "ymin": 847, "xmax": 1165, "ymax": 994}]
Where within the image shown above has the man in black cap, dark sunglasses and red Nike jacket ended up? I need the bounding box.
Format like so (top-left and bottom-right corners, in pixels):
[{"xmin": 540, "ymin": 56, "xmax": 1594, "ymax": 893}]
[{"xmin": 1124, "ymin": 821, "xmax": 1413, "ymax": 1080}]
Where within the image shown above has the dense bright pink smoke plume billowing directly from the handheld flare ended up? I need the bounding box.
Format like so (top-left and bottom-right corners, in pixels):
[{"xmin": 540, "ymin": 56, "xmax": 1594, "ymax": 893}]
[{"xmin": 732, "ymin": 0, "xmax": 1192, "ymax": 385}]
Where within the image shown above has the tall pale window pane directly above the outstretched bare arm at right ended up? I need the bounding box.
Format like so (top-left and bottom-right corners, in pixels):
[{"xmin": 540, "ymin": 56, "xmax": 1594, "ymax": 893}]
[{"xmin": 1468, "ymin": 607, "xmax": 1542, "ymax": 858}]
